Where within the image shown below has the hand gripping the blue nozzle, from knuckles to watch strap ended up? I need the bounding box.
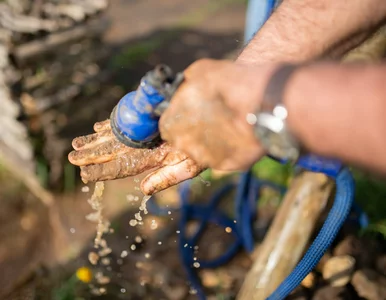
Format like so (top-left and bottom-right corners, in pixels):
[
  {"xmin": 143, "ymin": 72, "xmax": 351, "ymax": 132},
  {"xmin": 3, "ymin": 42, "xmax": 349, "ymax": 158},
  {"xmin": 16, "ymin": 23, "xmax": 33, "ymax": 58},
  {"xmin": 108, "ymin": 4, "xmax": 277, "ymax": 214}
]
[{"xmin": 160, "ymin": 60, "xmax": 268, "ymax": 171}]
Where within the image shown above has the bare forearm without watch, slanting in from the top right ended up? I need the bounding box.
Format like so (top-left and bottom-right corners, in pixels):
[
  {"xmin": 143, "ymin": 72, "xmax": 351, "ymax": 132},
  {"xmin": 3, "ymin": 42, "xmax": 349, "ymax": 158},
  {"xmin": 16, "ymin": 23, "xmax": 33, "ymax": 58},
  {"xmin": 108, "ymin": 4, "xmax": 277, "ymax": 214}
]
[{"xmin": 236, "ymin": 0, "xmax": 386, "ymax": 64}]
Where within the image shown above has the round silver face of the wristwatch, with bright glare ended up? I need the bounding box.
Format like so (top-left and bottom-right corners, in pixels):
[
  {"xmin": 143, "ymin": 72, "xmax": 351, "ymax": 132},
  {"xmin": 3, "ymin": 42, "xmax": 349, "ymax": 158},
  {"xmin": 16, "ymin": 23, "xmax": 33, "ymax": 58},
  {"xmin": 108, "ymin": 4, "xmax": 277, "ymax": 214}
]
[{"xmin": 256, "ymin": 114, "xmax": 299, "ymax": 160}]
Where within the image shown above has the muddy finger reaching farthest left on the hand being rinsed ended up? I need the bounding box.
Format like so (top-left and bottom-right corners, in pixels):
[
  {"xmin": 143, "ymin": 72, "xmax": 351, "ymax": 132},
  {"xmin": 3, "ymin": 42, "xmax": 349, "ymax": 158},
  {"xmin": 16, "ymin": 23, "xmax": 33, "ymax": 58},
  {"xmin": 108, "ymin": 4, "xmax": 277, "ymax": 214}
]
[{"xmin": 68, "ymin": 139, "xmax": 127, "ymax": 166}]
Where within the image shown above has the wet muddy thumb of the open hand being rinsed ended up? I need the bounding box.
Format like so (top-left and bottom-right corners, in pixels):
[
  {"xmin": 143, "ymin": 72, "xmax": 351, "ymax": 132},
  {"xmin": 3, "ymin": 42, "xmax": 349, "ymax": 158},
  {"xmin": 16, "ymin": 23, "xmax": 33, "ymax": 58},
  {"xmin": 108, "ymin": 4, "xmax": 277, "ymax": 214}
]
[{"xmin": 141, "ymin": 158, "xmax": 205, "ymax": 195}]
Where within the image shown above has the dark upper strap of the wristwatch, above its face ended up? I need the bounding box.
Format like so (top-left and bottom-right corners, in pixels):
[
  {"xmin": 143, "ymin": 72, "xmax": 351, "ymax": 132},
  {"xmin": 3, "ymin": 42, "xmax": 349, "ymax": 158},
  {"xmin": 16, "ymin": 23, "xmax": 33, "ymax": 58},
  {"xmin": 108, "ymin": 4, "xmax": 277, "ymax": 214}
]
[{"xmin": 260, "ymin": 64, "xmax": 299, "ymax": 112}]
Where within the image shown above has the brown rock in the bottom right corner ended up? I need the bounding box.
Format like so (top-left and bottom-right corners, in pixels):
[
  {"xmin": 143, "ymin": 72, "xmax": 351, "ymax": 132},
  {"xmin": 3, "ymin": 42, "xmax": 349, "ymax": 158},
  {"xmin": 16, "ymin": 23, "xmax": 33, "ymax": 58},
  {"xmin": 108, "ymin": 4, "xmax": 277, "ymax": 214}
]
[{"xmin": 351, "ymin": 269, "xmax": 386, "ymax": 300}]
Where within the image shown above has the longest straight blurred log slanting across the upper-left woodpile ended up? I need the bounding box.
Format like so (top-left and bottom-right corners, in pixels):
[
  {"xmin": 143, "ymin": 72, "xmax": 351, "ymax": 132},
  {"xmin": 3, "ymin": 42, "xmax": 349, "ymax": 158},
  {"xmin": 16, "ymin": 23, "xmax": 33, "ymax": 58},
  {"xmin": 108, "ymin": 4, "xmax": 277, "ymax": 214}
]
[{"xmin": 13, "ymin": 18, "xmax": 110, "ymax": 66}]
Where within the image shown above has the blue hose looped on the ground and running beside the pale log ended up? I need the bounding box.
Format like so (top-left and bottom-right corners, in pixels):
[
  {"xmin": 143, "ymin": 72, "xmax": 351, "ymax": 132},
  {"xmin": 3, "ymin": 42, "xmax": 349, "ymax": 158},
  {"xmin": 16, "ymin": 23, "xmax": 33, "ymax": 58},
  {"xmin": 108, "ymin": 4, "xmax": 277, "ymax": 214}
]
[{"xmin": 148, "ymin": 168, "xmax": 354, "ymax": 300}]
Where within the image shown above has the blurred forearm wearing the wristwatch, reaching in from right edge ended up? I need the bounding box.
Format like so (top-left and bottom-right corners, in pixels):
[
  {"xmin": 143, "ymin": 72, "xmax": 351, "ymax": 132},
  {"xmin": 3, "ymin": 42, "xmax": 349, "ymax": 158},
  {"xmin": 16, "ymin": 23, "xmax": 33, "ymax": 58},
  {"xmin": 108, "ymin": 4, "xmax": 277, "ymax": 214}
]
[{"xmin": 284, "ymin": 64, "xmax": 386, "ymax": 173}]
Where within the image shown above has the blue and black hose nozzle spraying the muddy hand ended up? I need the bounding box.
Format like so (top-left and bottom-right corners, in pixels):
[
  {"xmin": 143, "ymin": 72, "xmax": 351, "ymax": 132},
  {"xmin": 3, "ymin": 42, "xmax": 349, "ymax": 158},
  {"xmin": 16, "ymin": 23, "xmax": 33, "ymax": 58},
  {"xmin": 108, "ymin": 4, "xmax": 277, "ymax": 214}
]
[{"xmin": 110, "ymin": 65, "xmax": 183, "ymax": 148}]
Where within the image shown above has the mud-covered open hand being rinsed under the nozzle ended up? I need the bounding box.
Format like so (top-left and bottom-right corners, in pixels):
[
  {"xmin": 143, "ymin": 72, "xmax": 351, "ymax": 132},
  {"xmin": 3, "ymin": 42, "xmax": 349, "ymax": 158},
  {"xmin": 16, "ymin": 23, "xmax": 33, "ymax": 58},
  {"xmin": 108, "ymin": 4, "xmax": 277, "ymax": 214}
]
[{"xmin": 68, "ymin": 120, "xmax": 204, "ymax": 195}]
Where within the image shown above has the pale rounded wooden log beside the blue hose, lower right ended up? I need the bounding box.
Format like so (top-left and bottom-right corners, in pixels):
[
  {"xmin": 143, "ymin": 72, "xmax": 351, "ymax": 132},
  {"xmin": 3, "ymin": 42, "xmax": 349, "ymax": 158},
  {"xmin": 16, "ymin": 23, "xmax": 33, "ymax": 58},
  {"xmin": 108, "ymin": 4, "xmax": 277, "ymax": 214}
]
[{"xmin": 237, "ymin": 172, "xmax": 333, "ymax": 300}]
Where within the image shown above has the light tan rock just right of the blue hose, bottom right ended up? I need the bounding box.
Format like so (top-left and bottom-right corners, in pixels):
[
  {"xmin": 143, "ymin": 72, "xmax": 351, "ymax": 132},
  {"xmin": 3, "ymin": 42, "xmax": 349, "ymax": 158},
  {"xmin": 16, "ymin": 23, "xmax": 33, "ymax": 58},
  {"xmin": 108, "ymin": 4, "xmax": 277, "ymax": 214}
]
[{"xmin": 322, "ymin": 255, "xmax": 355, "ymax": 287}]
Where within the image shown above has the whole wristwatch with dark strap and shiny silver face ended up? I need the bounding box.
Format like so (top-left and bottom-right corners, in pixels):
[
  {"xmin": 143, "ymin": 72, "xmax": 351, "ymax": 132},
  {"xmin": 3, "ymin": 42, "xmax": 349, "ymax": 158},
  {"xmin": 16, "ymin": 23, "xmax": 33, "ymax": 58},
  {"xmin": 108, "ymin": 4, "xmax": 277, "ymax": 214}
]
[{"xmin": 247, "ymin": 64, "xmax": 300, "ymax": 163}]
